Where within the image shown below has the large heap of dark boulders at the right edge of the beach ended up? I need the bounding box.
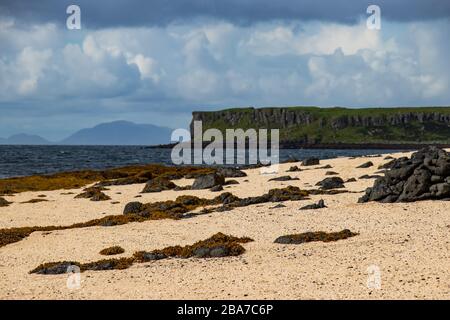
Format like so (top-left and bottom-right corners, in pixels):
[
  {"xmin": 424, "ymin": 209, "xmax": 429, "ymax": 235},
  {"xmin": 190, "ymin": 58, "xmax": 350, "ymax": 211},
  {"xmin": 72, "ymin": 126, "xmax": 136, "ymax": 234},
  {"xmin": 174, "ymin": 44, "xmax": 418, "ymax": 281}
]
[{"xmin": 358, "ymin": 147, "xmax": 450, "ymax": 203}]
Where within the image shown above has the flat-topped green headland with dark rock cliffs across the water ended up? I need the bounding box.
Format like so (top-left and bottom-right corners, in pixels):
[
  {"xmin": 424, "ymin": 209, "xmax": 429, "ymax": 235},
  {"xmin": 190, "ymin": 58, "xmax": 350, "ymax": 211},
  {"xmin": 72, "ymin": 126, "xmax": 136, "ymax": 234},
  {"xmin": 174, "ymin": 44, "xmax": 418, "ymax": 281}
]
[{"xmin": 191, "ymin": 107, "xmax": 450, "ymax": 148}]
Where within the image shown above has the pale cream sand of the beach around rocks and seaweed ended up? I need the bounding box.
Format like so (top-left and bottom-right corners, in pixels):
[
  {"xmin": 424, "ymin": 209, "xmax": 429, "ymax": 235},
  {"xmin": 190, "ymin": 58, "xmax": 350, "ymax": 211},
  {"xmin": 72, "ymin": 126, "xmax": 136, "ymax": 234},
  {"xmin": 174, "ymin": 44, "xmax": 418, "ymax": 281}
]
[{"xmin": 0, "ymin": 153, "xmax": 450, "ymax": 300}]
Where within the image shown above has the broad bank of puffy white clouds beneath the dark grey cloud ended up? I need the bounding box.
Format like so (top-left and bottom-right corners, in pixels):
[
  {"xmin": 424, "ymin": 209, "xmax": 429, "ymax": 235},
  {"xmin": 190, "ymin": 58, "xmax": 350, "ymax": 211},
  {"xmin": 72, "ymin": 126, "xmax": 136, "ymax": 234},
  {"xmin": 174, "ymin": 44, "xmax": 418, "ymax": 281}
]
[{"xmin": 0, "ymin": 20, "xmax": 450, "ymax": 135}]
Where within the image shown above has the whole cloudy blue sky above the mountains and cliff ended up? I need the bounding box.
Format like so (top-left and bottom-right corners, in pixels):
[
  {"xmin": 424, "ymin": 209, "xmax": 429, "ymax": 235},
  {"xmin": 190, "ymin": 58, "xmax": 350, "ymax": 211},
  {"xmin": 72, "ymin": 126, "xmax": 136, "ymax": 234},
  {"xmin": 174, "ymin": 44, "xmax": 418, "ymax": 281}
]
[{"xmin": 0, "ymin": 0, "xmax": 450, "ymax": 140}]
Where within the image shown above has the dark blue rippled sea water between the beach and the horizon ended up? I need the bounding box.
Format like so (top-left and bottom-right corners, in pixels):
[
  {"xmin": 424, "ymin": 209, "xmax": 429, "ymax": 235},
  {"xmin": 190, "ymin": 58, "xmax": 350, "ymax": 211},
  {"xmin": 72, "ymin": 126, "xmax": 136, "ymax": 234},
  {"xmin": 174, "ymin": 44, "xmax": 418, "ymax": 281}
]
[{"xmin": 0, "ymin": 145, "xmax": 400, "ymax": 178}]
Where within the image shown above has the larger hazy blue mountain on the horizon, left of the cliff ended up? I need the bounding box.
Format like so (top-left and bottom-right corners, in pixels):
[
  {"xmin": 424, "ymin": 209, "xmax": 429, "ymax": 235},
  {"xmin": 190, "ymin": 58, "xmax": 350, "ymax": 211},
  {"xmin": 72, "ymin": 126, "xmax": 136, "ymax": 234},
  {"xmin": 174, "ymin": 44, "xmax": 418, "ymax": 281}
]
[{"xmin": 60, "ymin": 121, "xmax": 172, "ymax": 145}]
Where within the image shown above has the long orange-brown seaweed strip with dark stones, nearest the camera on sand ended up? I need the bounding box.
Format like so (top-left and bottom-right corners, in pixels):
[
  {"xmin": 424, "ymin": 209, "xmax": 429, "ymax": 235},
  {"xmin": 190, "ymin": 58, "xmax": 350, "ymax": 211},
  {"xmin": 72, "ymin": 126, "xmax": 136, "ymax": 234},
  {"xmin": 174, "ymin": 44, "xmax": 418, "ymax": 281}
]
[{"xmin": 30, "ymin": 232, "xmax": 253, "ymax": 275}]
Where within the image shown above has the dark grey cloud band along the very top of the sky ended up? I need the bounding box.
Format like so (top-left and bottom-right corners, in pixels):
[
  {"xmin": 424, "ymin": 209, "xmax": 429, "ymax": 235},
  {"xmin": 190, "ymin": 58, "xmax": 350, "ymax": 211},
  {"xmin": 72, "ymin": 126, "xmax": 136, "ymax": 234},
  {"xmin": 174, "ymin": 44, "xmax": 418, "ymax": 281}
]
[{"xmin": 0, "ymin": 0, "xmax": 450, "ymax": 28}]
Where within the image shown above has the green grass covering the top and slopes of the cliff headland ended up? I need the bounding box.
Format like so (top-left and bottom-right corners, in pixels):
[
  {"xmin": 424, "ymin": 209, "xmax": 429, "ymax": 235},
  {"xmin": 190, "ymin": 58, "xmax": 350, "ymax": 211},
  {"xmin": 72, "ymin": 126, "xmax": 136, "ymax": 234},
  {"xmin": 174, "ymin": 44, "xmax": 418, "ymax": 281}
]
[{"xmin": 201, "ymin": 107, "xmax": 450, "ymax": 144}]
